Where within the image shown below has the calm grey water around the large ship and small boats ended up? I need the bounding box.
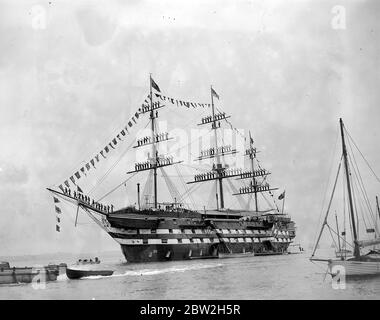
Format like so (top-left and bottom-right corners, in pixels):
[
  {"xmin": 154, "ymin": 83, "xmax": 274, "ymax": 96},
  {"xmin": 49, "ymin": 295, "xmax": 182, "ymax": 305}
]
[{"xmin": 0, "ymin": 253, "xmax": 380, "ymax": 300}]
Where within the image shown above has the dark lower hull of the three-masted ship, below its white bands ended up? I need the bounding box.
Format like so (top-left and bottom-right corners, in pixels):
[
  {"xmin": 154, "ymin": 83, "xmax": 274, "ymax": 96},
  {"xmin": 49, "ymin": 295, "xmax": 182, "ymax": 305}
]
[{"xmin": 121, "ymin": 243, "xmax": 288, "ymax": 263}]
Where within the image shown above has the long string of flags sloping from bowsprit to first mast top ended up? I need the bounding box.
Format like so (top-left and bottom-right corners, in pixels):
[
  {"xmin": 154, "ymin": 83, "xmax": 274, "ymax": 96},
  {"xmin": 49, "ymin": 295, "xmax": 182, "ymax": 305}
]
[{"xmin": 59, "ymin": 95, "xmax": 150, "ymax": 192}]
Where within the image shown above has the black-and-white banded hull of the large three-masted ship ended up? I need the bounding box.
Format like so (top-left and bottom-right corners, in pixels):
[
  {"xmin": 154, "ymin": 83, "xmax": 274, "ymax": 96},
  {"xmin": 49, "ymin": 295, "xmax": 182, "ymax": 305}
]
[{"xmin": 105, "ymin": 211, "xmax": 295, "ymax": 263}]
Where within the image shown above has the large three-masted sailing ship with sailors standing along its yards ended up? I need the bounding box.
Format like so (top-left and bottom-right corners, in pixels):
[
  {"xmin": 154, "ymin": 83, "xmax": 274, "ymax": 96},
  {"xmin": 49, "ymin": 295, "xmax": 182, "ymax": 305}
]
[{"xmin": 48, "ymin": 76, "xmax": 296, "ymax": 263}]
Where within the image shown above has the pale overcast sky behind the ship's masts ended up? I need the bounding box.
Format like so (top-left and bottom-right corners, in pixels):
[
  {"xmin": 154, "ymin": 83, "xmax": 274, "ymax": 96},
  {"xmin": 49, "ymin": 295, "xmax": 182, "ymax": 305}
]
[{"xmin": 0, "ymin": 0, "xmax": 380, "ymax": 256}]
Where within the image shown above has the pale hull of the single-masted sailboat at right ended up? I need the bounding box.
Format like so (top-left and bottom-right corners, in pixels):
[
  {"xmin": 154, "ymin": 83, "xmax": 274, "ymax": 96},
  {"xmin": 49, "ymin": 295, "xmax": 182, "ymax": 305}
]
[{"xmin": 328, "ymin": 260, "xmax": 380, "ymax": 277}]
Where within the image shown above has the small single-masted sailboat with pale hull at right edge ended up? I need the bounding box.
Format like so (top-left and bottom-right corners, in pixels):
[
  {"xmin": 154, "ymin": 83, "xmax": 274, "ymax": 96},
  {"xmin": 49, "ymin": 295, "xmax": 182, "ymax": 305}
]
[{"xmin": 310, "ymin": 119, "xmax": 380, "ymax": 277}]
